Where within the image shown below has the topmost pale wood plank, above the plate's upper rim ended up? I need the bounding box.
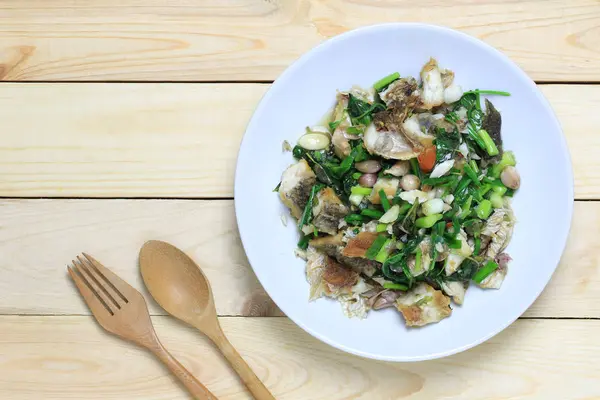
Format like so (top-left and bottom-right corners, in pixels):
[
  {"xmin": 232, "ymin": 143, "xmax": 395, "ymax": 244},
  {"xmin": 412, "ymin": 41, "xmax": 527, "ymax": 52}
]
[{"xmin": 0, "ymin": 0, "xmax": 600, "ymax": 81}]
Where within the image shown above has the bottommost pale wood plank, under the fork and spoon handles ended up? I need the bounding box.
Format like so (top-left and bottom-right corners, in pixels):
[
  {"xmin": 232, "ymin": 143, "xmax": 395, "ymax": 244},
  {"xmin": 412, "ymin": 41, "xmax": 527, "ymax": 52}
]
[{"xmin": 0, "ymin": 317, "xmax": 600, "ymax": 400}]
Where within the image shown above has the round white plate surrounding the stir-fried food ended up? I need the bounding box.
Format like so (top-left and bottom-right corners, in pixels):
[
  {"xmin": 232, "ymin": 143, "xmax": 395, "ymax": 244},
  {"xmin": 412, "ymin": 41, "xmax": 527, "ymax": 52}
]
[{"xmin": 235, "ymin": 24, "xmax": 573, "ymax": 361}]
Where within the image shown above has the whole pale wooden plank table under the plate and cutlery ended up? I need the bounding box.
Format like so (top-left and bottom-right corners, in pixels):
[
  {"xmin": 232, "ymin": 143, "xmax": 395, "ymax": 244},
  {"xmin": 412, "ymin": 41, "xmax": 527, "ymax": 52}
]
[{"xmin": 0, "ymin": 0, "xmax": 600, "ymax": 400}]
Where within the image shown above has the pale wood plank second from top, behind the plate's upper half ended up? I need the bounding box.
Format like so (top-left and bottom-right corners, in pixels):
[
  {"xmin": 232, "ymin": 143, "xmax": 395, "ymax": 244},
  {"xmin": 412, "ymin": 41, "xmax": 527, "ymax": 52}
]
[{"xmin": 0, "ymin": 83, "xmax": 600, "ymax": 199}]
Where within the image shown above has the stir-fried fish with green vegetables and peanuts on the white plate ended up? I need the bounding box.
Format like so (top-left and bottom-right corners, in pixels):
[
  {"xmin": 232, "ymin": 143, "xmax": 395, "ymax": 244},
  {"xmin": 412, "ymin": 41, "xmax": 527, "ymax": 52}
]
[{"xmin": 276, "ymin": 59, "xmax": 520, "ymax": 326}]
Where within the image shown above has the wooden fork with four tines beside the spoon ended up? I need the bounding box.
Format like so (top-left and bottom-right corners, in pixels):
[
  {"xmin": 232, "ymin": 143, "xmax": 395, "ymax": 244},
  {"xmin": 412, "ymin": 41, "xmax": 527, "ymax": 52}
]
[{"xmin": 68, "ymin": 253, "xmax": 217, "ymax": 400}]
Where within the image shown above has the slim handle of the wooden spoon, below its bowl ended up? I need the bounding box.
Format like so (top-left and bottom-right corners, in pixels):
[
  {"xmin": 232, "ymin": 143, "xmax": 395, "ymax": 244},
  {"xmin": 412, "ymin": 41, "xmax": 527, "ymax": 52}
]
[{"xmin": 209, "ymin": 327, "xmax": 275, "ymax": 400}]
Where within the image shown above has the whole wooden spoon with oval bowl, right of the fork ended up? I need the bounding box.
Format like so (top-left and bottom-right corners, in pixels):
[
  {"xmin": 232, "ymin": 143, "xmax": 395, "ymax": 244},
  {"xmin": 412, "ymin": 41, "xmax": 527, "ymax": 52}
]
[{"xmin": 140, "ymin": 240, "xmax": 275, "ymax": 400}]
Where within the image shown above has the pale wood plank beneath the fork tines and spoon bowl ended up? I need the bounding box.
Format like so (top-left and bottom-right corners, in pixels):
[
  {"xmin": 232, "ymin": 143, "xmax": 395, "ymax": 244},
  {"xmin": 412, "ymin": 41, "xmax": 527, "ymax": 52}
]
[{"xmin": 0, "ymin": 200, "xmax": 600, "ymax": 318}]
